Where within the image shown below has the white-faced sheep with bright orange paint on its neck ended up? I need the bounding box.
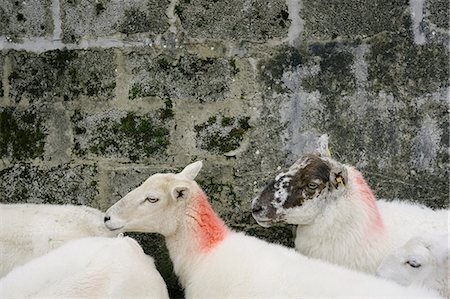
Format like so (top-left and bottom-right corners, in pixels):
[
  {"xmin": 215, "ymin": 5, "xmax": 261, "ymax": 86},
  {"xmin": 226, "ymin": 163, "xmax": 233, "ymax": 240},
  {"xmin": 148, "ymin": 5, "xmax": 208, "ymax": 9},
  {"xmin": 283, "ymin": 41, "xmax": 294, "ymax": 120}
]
[{"xmin": 104, "ymin": 161, "xmax": 437, "ymax": 299}]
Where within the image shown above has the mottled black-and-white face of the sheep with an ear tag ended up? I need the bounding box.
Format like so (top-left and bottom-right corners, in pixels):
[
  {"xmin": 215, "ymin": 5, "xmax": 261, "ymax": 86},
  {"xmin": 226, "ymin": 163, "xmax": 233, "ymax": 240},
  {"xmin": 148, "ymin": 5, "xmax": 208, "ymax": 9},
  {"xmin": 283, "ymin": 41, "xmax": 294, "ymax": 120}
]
[{"xmin": 252, "ymin": 154, "xmax": 347, "ymax": 227}]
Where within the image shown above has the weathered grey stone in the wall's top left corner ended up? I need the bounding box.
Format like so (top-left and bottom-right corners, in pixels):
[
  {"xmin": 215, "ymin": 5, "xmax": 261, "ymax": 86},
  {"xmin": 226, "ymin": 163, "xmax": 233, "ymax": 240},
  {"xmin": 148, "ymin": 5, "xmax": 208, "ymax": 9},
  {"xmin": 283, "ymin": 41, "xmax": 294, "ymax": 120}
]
[{"xmin": 0, "ymin": 0, "xmax": 53, "ymax": 41}]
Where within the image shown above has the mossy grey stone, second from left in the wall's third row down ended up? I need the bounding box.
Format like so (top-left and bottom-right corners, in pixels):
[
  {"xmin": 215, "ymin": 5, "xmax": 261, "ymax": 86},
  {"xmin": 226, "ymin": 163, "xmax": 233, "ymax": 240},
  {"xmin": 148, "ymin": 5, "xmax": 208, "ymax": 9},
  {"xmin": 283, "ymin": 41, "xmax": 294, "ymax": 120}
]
[{"xmin": 72, "ymin": 110, "xmax": 170, "ymax": 161}]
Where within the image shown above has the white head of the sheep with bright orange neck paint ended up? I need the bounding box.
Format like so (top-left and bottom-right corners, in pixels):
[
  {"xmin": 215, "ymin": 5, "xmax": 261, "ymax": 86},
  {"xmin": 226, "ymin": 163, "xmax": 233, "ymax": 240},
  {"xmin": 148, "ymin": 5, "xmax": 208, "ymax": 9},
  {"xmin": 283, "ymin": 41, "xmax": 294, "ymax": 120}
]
[{"xmin": 105, "ymin": 161, "xmax": 202, "ymax": 236}]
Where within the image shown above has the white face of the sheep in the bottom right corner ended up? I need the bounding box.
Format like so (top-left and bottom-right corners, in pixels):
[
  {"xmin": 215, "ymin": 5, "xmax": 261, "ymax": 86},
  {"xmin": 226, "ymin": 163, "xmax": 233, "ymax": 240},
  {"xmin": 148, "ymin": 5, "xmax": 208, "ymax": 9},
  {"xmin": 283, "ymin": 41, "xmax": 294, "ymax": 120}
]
[{"xmin": 377, "ymin": 239, "xmax": 438, "ymax": 286}]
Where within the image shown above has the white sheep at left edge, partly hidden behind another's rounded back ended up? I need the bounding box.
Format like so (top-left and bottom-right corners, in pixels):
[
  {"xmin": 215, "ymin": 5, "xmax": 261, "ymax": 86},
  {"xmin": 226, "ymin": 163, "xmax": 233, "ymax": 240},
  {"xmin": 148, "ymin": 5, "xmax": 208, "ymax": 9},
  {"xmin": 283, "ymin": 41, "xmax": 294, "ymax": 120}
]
[{"xmin": 0, "ymin": 204, "xmax": 117, "ymax": 277}]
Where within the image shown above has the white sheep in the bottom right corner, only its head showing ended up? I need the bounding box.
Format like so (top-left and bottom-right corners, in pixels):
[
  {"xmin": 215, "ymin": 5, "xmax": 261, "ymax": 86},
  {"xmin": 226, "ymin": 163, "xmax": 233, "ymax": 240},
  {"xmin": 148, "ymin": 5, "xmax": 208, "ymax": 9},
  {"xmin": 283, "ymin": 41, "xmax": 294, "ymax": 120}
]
[{"xmin": 377, "ymin": 234, "xmax": 450, "ymax": 298}]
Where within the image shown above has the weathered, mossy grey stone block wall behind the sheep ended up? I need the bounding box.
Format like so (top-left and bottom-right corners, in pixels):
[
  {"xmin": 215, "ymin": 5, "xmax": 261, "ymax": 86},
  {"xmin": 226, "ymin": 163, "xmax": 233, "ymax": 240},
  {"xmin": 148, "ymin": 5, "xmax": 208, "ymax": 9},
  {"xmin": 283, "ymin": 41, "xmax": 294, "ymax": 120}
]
[{"xmin": 0, "ymin": 0, "xmax": 449, "ymax": 297}]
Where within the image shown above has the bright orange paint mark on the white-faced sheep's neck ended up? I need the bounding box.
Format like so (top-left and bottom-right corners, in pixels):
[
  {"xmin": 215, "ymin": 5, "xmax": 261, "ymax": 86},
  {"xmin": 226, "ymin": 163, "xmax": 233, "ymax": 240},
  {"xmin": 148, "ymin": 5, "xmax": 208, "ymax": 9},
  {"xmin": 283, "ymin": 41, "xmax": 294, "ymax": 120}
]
[{"xmin": 194, "ymin": 190, "xmax": 229, "ymax": 251}]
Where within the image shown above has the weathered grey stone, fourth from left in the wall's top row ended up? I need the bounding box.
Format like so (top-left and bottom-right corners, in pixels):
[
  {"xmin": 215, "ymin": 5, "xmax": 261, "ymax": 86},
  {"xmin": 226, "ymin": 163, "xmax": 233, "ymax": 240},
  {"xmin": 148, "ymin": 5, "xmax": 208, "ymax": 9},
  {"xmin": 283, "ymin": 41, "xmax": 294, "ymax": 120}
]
[{"xmin": 300, "ymin": 0, "xmax": 410, "ymax": 40}]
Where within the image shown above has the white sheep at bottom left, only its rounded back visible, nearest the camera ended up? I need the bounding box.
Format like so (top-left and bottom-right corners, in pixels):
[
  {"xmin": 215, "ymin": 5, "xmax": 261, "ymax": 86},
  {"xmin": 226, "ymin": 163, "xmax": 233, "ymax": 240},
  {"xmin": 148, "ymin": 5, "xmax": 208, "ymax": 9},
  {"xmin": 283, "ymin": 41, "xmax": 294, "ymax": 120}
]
[{"xmin": 0, "ymin": 237, "xmax": 169, "ymax": 299}]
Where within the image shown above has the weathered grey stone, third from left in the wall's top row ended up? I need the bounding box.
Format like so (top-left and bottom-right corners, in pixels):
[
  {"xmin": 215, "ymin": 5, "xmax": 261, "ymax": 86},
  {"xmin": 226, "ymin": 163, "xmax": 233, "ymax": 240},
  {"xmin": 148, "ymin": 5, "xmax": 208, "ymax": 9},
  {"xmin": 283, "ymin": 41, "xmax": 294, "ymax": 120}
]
[{"xmin": 175, "ymin": 0, "xmax": 290, "ymax": 41}]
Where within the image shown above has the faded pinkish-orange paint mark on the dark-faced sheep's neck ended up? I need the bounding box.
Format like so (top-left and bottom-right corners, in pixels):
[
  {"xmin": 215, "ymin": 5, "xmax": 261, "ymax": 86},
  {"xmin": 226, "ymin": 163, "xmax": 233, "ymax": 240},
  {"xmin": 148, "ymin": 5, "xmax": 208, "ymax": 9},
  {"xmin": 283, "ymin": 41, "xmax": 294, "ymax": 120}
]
[{"xmin": 352, "ymin": 170, "xmax": 384, "ymax": 231}]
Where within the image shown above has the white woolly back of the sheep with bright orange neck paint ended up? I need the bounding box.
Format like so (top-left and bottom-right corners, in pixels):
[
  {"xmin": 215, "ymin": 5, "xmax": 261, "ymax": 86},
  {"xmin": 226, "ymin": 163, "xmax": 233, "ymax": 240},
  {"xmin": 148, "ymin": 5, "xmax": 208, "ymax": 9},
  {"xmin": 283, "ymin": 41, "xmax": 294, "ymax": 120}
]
[{"xmin": 186, "ymin": 233, "xmax": 442, "ymax": 298}]
